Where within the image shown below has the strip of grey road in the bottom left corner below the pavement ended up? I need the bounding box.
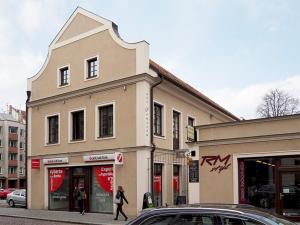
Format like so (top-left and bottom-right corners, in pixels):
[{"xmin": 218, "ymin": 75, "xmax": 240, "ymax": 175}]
[{"xmin": 0, "ymin": 216, "xmax": 79, "ymax": 225}]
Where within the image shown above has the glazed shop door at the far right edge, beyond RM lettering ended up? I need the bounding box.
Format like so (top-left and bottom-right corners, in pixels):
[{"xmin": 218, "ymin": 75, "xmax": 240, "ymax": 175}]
[{"xmin": 279, "ymin": 170, "xmax": 300, "ymax": 221}]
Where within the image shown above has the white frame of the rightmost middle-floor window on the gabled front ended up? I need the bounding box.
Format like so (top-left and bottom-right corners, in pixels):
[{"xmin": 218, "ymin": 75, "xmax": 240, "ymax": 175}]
[{"xmin": 95, "ymin": 100, "xmax": 116, "ymax": 140}]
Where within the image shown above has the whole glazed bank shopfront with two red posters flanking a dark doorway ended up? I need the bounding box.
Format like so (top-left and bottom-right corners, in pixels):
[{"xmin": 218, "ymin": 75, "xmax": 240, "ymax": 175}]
[{"xmin": 48, "ymin": 164, "xmax": 114, "ymax": 213}]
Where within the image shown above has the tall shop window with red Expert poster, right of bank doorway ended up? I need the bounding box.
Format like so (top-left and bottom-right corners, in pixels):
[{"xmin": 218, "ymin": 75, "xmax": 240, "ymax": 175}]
[{"xmin": 90, "ymin": 165, "xmax": 114, "ymax": 213}]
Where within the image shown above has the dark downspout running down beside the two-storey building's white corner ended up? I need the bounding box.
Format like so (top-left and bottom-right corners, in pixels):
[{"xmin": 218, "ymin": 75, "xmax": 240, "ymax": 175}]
[{"xmin": 150, "ymin": 75, "xmax": 163, "ymax": 197}]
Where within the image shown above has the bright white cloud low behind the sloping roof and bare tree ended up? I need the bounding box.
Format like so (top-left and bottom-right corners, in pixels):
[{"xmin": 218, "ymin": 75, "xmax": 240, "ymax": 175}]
[{"xmin": 205, "ymin": 75, "xmax": 300, "ymax": 119}]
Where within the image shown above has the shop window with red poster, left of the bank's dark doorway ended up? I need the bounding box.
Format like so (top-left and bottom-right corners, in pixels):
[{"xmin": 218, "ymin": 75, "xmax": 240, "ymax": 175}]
[{"xmin": 48, "ymin": 168, "xmax": 69, "ymax": 210}]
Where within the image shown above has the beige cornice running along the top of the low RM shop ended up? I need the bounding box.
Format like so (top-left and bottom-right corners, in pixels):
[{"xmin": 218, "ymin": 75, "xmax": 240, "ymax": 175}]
[{"xmin": 187, "ymin": 132, "xmax": 300, "ymax": 147}]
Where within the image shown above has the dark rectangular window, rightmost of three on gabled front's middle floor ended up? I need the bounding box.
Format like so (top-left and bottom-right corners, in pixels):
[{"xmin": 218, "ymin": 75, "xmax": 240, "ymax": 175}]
[{"xmin": 98, "ymin": 105, "xmax": 114, "ymax": 138}]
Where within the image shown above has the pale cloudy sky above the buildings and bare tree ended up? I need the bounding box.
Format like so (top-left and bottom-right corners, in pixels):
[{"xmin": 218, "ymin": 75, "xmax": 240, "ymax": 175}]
[{"xmin": 0, "ymin": 0, "xmax": 300, "ymax": 119}]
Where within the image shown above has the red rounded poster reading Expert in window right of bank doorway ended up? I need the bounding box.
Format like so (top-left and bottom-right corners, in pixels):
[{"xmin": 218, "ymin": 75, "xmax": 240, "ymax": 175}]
[{"xmin": 94, "ymin": 165, "xmax": 114, "ymax": 192}]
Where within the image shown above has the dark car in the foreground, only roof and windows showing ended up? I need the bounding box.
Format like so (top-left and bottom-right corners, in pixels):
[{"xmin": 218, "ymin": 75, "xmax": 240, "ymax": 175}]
[{"xmin": 127, "ymin": 204, "xmax": 295, "ymax": 225}]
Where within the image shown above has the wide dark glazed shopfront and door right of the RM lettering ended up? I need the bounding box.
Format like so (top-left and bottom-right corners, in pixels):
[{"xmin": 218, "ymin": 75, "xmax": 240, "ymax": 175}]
[{"xmin": 239, "ymin": 156, "xmax": 300, "ymax": 221}]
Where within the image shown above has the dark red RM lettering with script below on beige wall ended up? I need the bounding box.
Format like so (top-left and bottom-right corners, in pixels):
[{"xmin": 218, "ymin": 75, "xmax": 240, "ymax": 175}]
[{"xmin": 201, "ymin": 155, "xmax": 231, "ymax": 173}]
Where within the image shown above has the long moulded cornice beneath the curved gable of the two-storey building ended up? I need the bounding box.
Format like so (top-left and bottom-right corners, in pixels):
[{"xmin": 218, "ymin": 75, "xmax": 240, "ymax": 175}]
[{"xmin": 28, "ymin": 74, "xmax": 155, "ymax": 107}]
